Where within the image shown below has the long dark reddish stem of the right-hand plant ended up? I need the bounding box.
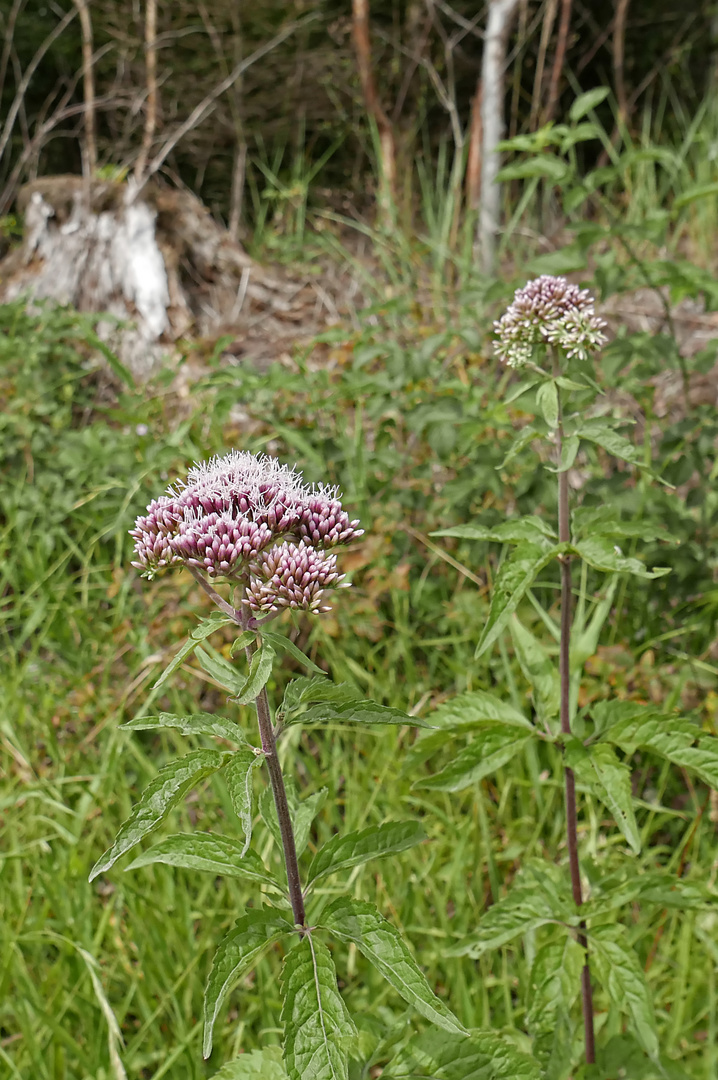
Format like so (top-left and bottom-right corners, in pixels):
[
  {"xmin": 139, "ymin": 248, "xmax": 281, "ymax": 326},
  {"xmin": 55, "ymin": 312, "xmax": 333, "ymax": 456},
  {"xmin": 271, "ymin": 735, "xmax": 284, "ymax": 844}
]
[{"xmin": 556, "ymin": 371, "xmax": 596, "ymax": 1065}]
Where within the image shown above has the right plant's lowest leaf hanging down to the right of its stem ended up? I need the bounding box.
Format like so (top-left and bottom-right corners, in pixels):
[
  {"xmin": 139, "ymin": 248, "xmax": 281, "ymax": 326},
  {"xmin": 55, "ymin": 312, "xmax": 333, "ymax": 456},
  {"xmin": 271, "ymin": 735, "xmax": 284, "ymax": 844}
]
[{"xmin": 591, "ymin": 927, "xmax": 659, "ymax": 1058}]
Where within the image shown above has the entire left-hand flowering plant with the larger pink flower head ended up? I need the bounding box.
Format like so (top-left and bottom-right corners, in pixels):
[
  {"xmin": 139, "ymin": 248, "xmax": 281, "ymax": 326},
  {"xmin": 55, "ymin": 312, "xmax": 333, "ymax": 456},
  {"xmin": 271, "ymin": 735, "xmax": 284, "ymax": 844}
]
[{"xmin": 91, "ymin": 451, "xmax": 464, "ymax": 1080}]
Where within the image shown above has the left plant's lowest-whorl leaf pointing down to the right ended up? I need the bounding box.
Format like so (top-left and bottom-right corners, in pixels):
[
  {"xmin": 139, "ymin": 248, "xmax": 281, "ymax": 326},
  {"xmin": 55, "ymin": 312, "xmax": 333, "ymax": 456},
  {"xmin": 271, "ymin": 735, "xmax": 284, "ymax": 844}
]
[{"xmin": 322, "ymin": 896, "xmax": 465, "ymax": 1032}]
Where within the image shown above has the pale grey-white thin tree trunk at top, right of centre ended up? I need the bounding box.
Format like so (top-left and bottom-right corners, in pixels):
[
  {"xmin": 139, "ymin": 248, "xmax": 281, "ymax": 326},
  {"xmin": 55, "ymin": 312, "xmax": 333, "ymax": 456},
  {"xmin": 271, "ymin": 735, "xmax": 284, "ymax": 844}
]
[{"xmin": 478, "ymin": 0, "xmax": 519, "ymax": 274}]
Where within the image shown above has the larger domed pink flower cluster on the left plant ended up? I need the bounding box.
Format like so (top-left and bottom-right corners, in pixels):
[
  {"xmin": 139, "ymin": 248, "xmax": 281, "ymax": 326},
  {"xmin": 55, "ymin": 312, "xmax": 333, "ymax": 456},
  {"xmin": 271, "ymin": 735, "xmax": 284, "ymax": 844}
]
[{"xmin": 131, "ymin": 450, "xmax": 363, "ymax": 612}]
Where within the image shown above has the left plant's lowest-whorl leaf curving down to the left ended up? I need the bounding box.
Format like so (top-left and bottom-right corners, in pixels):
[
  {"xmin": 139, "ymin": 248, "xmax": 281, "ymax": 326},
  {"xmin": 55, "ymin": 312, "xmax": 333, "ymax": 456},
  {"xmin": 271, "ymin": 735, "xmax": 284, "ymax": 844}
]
[{"xmin": 203, "ymin": 908, "xmax": 294, "ymax": 1057}]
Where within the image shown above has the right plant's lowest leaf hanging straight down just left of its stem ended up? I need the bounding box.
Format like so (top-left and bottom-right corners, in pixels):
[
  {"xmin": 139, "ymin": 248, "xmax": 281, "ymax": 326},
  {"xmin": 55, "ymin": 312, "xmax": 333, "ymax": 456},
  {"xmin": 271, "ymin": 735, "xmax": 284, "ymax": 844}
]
[{"xmin": 526, "ymin": 935, "xmax": 584, "ymax": 1078}]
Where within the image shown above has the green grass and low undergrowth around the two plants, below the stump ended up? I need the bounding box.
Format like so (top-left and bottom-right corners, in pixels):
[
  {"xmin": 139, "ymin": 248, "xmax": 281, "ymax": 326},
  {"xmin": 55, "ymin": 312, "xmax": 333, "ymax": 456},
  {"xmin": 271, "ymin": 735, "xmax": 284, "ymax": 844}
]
[{"xmin": 0, "ymin": 217, "xmax": 718, "ymax": 1080}]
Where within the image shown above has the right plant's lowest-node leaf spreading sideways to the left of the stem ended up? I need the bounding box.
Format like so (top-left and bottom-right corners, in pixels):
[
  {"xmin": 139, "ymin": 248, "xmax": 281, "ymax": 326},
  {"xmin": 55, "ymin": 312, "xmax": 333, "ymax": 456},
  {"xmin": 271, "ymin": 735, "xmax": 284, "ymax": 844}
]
[{"xmin": 446, "ymin": 864, "xmax": 578, "ymax": 959}]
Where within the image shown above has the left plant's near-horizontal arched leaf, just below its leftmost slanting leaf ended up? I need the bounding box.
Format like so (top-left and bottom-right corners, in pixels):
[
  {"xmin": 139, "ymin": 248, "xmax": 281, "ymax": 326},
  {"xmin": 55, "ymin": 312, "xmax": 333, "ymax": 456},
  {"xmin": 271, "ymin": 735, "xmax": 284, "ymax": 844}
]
[{"xmin": 127, "ymin": 833, "xmax": 281, "ymax": 889}]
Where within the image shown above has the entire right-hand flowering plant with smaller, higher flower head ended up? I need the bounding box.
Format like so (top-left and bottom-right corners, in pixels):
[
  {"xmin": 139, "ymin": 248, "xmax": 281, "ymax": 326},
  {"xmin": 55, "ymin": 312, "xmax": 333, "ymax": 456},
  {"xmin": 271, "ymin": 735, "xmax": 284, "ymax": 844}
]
[{"xmin": 414, "ymin": 275, "xmax": 718, "ymax": 1080}]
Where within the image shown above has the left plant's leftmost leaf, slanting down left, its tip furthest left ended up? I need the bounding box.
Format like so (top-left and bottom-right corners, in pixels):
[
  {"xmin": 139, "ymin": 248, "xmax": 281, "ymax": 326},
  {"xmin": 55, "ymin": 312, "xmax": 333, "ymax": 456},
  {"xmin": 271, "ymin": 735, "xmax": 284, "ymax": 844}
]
[{"xmin": 90, "ymin": 750, "xmax": 229, "ymax": 881}]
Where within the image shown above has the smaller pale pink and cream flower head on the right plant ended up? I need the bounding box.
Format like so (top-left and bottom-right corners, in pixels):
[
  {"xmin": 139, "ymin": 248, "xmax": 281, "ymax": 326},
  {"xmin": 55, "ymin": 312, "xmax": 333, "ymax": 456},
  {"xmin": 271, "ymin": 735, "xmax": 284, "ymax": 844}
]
[{"xmin": 493, "ymin": 274, "xmax": 606, "ymax": 367}]
